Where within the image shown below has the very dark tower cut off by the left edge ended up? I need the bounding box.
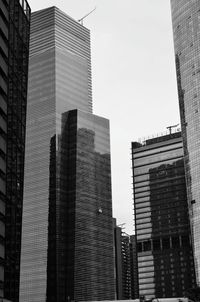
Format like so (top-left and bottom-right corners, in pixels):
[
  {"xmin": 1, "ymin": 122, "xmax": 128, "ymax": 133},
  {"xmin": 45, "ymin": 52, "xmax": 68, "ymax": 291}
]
[{"xmin": 0, "ymin": 0, "xmax": 30, "ymax": 302}]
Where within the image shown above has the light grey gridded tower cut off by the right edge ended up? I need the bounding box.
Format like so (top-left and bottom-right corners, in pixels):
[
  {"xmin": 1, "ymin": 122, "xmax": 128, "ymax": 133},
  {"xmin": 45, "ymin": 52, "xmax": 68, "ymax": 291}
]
[{"xmin": 171, "ymin": 0, "xmax": 200, "ymax": 285}]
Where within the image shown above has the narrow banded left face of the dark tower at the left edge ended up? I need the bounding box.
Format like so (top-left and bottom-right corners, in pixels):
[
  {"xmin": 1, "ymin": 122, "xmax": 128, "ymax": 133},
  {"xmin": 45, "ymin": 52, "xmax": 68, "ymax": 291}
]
[{"xmin": 0, "ymin": 0, "xmax": 9, "ymax": 297}]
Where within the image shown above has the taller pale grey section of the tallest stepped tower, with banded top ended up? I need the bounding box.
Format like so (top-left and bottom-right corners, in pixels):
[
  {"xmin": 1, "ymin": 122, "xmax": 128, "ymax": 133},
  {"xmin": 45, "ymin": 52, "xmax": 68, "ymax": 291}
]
[{"xmin": 20, "ymin": 7, "xmax": 91, "ymax": 302}]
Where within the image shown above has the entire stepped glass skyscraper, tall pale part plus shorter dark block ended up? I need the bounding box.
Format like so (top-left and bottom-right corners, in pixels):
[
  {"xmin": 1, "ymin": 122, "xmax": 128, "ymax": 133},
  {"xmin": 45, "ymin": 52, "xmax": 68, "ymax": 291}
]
[{"xmin": 20, "ymin": 7, "xmax": 115, "ymax": 302}]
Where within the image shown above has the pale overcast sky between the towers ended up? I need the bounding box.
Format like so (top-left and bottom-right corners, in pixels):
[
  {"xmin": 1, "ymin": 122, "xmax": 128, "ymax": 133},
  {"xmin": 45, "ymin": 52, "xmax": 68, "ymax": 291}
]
[{"xmin": 28, "ymin": 0, "xmax": 179, "ymax": 235}]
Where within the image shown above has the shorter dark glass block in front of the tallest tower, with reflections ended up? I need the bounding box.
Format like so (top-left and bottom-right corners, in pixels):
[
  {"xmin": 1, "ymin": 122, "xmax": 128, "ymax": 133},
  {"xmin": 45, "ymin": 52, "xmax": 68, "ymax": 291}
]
[{"xmin": 60, "ymin": 110, "xmax": 115, "ymax": 301}]
